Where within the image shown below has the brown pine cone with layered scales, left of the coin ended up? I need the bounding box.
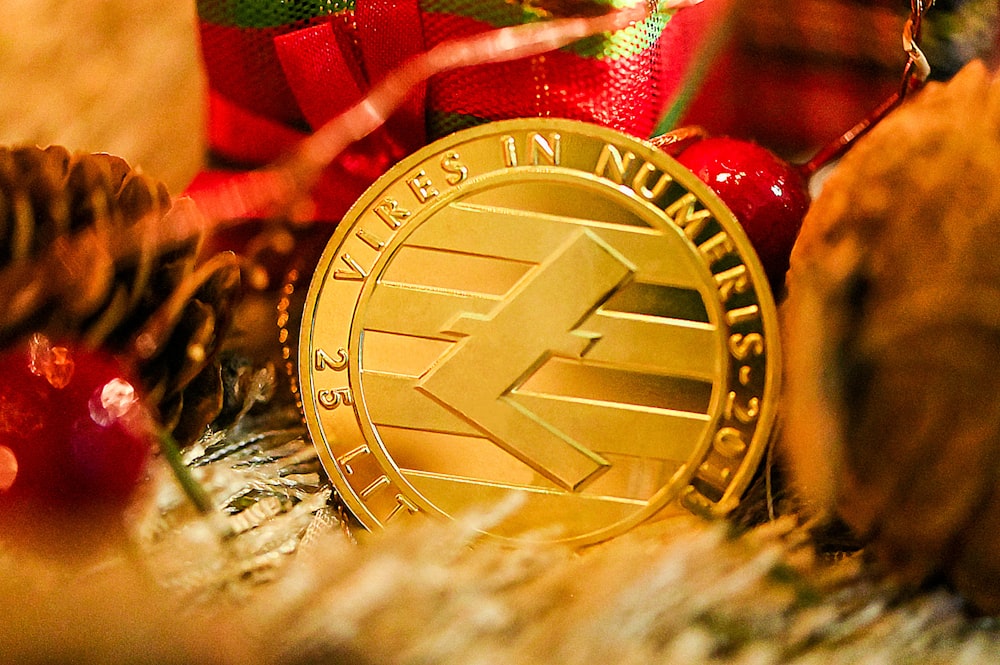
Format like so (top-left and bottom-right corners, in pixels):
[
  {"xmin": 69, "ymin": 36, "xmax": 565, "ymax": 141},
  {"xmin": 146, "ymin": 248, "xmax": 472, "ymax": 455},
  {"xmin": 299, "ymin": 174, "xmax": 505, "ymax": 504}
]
[{"xmin": 0, "ymin": 146, "xmax": 239, "ymax": 444}]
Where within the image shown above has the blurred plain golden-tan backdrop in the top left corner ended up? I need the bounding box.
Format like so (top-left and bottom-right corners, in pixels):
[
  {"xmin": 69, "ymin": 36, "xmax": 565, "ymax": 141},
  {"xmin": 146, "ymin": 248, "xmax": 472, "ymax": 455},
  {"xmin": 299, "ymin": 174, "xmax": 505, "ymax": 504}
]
[{"xmin": 0, "ymin": 0, "xmax": 205, "ymax": 192}]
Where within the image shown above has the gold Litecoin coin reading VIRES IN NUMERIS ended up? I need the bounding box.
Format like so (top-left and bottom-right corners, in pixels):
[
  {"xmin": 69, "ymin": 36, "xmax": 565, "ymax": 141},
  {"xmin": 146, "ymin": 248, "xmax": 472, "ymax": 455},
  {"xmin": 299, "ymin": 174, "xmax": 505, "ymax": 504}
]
[{"xmin": 298, "ymin": 119, "xmax": 779, "ymax": 545}]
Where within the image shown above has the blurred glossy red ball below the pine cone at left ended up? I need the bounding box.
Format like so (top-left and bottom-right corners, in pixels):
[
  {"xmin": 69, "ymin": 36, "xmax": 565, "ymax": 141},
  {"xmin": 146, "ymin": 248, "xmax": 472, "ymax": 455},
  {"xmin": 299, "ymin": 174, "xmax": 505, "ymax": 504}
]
[{"xmin": 0, "ymin": 335, "xmax": 151, "ymax": 523}]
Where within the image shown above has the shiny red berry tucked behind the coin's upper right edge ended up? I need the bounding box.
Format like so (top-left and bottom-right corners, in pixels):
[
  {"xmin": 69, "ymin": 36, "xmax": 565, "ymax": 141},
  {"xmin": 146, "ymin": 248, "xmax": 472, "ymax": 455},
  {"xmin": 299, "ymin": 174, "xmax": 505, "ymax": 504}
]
[{"xmin": 677, "ymin": 137, "xmax": 809, "ymax": 293}]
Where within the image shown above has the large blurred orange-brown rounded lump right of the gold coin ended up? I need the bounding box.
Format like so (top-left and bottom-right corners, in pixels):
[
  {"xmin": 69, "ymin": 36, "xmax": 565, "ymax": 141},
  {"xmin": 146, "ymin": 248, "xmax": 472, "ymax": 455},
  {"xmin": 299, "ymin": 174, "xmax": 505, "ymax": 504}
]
[{"xmin": 783, "ymin": 62, "xmax": 1000, "ymax": 612}]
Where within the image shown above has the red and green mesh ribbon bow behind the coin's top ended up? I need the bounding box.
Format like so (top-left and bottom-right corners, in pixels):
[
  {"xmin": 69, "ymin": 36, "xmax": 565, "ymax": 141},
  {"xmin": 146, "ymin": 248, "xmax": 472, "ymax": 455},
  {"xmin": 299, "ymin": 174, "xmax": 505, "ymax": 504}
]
[{"xmin": 192, "ymin": 0, "xmax": 680, "ymax": 221}]
